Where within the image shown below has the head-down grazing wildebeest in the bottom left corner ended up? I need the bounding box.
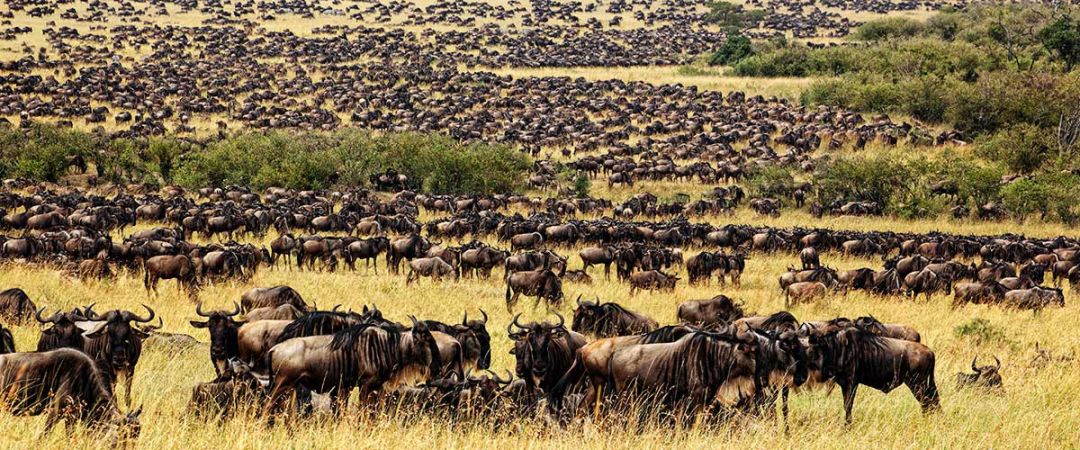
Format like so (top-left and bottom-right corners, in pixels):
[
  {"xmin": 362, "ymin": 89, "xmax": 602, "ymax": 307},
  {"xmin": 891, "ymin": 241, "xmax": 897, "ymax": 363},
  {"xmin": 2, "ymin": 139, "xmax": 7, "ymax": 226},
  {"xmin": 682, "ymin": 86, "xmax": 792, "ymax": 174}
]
[{"xmin": 0, "ymin": 349, "xmax": 141, "ymax": 445}]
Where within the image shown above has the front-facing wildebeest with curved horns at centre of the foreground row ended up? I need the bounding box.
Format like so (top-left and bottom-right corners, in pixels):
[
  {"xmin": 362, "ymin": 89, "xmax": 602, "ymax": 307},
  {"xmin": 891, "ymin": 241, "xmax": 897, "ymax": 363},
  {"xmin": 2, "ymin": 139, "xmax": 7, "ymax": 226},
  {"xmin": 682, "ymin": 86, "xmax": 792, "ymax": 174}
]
[{"xmin": 507, "ymin": 313, "xmax": 586, "ymax": 393}]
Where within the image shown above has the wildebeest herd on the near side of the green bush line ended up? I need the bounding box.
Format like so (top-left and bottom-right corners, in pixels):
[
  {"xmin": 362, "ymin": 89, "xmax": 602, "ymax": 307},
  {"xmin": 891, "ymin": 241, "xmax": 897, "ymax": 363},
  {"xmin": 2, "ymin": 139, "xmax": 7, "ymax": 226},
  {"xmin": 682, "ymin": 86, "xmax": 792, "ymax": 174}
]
[{"xmin": 0, "ymin": 180, "xmax": 1067, "ymax": 439}]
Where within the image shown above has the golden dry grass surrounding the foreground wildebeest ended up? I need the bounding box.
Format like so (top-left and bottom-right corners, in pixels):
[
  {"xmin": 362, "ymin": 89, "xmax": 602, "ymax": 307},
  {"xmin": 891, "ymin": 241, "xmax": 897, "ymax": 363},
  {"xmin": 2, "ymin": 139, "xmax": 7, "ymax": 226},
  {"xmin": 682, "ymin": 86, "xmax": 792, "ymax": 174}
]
[{"xmin": 0, "ymin": 214, "xmax": 1080, "ymax": 449}]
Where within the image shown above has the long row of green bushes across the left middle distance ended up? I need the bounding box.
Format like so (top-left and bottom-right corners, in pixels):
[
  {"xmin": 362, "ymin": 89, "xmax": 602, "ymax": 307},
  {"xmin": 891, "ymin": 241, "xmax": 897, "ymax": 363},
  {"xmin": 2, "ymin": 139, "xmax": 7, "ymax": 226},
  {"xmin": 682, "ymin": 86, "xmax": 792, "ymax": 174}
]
[{"xmin": 0, "ymin": 124, "xmax": 531, "ymax": 194}]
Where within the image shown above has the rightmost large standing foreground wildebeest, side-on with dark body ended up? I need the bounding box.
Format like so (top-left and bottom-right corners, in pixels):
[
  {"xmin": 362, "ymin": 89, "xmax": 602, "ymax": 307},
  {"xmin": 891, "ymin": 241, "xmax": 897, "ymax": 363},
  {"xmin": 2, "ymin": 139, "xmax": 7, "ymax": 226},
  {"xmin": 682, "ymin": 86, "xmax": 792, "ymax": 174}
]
[{"xmin": 808, "ymin": 327, "xmax": 941, "ymax": 423}]
